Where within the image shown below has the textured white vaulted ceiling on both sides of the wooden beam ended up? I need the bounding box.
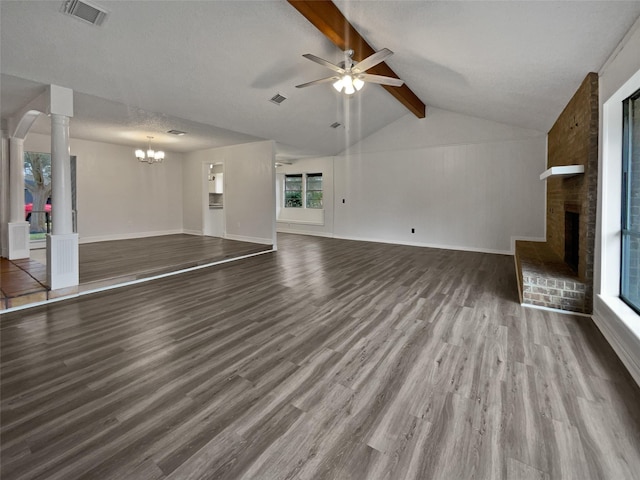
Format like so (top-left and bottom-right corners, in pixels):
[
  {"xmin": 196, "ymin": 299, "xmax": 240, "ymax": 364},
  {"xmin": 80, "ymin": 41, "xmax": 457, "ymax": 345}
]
[{"xmin": 0, "ymin": 0, "xmax": 640, "ymax": 158}]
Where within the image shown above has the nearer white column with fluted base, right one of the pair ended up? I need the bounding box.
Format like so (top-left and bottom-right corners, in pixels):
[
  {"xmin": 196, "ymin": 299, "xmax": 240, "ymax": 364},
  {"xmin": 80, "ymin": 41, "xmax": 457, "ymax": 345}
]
[{"xmin": 47, "ymin": 113, "xmax": 79, "ymax": 290}]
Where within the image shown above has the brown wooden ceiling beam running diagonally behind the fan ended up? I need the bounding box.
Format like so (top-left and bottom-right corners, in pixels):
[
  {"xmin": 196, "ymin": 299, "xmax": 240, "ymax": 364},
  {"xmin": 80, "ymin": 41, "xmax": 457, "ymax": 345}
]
[{"xmin": 287, "ymin": 0, "xmax": 427, "ymax": 118}]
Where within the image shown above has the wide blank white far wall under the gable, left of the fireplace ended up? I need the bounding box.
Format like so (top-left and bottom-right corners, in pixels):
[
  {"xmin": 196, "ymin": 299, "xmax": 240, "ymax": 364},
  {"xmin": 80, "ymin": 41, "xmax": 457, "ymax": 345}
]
[{"xmin": 322, "ymin": 108, "xmax": 546, "ymax": 253}]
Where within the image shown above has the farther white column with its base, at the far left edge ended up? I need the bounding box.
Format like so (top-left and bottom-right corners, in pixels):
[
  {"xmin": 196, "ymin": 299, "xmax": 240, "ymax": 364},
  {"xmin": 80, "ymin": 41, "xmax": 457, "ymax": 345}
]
[{"xmin": 8, "ymin": 137, "xmax": 29, "ymax": 260}]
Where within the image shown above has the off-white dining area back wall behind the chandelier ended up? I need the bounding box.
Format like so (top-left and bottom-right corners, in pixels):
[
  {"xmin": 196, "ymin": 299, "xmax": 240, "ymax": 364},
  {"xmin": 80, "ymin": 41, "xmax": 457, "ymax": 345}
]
[{"xmin": 24, "ymin": 133, "xmax": 183, "ymax": 242}]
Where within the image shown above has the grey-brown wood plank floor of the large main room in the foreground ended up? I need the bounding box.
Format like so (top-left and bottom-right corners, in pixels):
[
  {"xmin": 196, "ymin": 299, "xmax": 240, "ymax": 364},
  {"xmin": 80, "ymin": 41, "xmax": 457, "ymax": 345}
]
[{"xmin": 0, "ymin": 235, "xmax": 640, "ymax": 480}]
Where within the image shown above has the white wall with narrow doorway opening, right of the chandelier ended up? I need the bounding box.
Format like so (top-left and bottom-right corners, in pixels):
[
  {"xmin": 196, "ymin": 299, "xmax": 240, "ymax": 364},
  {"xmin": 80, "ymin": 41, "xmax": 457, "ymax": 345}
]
[{"xmin": 182, "ymin": 141, "xmax": 276, "ymax": 246}]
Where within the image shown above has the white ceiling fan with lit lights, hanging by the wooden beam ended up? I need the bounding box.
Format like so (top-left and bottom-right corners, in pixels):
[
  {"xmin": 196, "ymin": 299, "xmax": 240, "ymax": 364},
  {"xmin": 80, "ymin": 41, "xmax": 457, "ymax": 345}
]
[{"xmin": 296, "ymin": 48, "xmax": 404, "ymax": 95}]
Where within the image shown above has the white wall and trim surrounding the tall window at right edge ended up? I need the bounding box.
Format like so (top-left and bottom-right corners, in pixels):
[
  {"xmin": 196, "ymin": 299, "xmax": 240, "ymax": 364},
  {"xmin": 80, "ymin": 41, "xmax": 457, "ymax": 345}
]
[{"xmin": 593, "ymin": 18, "xmax": 640, "ymax": 385}]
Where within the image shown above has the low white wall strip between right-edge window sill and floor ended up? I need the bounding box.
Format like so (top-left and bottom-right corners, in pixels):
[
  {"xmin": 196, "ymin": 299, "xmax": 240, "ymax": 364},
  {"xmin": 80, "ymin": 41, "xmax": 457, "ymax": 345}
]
[{"xmin": 592, "ymin": 296, "xmax": 640, "ymax": 386}]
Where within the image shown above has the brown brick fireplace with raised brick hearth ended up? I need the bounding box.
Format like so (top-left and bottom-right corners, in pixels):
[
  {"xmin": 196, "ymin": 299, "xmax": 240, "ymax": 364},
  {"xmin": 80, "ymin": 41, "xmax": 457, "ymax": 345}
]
[{"xmin": 516, "ymin": 73, "xmax": 598, "ymax": 313}]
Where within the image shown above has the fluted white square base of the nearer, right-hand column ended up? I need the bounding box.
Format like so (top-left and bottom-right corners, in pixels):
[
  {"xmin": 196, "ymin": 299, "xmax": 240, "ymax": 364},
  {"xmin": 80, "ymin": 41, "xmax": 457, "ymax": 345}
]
[{"xmin": 47, "ymin": 233, "xmax": 80, "ymax": 290}]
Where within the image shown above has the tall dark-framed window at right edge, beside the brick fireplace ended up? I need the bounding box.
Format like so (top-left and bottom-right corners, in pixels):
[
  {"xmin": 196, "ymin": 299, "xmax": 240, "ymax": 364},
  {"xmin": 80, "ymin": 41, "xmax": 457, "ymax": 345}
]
[{"xmin": 620, "ymin": 90, "xmax": 640, "ymax": 312}]
